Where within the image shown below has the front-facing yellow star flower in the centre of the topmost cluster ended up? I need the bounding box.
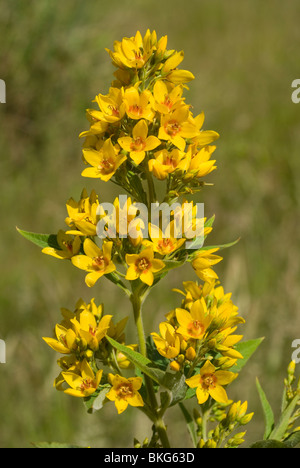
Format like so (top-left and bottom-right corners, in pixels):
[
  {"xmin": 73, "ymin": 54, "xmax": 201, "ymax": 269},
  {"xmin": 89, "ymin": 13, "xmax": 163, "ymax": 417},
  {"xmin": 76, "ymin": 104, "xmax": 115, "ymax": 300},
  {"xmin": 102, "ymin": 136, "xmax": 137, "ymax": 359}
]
[{"xmin": 118, "ymin": 119, "xmax": 161, "ymax": 164}]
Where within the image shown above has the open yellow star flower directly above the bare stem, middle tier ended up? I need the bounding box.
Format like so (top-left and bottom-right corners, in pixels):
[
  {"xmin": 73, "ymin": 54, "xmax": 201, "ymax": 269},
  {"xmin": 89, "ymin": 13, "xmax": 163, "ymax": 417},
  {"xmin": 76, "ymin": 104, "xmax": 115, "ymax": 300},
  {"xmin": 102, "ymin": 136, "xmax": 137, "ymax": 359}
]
[{"xmin": 125, "ymin": 246, "xmax": 165, "ymax": 286}]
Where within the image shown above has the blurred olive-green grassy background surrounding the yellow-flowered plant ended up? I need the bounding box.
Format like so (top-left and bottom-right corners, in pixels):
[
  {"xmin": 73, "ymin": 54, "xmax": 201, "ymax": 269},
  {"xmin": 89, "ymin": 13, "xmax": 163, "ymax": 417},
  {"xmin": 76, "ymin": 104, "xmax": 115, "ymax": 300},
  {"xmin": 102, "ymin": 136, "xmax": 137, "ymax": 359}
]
[{"xmin": 0, "ymin": 0, "xmax": 300, "ymax": 448}]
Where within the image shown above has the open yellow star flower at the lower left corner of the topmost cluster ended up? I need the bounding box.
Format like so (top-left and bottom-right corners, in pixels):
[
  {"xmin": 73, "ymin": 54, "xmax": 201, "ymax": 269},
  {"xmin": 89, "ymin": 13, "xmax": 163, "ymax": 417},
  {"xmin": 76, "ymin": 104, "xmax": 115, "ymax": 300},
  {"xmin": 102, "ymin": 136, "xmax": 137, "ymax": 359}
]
[{"xmin": 81, "ymin": 138, "xmax": 126, "ymax": 182}]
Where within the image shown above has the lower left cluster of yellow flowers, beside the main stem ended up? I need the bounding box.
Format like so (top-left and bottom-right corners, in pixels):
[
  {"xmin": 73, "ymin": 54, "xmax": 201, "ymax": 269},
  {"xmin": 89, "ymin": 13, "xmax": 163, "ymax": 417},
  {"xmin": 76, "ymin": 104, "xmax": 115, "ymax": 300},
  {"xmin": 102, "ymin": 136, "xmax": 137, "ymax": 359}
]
[{"xmin": 44, "ymin": 299, "xmax": 143, "ymax": 413}]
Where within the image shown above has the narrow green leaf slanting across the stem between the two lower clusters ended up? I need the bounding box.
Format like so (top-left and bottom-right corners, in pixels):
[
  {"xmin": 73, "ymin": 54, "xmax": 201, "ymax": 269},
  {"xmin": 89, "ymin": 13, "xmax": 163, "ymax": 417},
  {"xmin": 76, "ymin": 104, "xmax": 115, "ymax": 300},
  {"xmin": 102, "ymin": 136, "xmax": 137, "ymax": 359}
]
[{"xmin": 106, "ymin": 336, "xmax": 165, "ymax": 386}]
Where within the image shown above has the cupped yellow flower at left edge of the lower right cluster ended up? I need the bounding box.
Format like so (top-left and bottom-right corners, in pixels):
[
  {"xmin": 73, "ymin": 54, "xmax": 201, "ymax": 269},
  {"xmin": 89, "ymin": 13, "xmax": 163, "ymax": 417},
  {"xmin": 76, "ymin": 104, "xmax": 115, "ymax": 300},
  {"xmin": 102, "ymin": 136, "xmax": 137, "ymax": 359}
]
[{"xmin": 151, "ymin": 322, "xmax": 180, "ymax": 359}]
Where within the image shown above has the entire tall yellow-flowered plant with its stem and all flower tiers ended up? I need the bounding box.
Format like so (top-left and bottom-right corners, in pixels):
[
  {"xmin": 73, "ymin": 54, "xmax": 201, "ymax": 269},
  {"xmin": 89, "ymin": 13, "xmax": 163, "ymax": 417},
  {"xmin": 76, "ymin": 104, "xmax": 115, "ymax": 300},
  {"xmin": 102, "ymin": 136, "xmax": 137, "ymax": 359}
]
[{"xmin": 19, "ymin": 30, "xmax": 255, "ymax": 447}]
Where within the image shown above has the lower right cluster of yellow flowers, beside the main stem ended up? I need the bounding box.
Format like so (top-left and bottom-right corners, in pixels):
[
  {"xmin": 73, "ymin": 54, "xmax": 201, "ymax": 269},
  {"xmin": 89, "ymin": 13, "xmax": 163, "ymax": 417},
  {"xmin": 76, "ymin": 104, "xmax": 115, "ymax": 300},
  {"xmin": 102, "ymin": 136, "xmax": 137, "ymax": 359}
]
[{"xmin": 151, "ymin": 280, "xmax": 244, "ymax": 404}]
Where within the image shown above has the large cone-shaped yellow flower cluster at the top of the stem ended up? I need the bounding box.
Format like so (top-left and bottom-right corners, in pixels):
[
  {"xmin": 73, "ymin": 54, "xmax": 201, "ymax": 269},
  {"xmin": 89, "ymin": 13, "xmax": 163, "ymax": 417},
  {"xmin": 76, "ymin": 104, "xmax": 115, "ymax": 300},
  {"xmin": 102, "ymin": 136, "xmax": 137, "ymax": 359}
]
[{"xmin": 80, "ymin": 30, "xmax": 219, "ymax": 196}]
